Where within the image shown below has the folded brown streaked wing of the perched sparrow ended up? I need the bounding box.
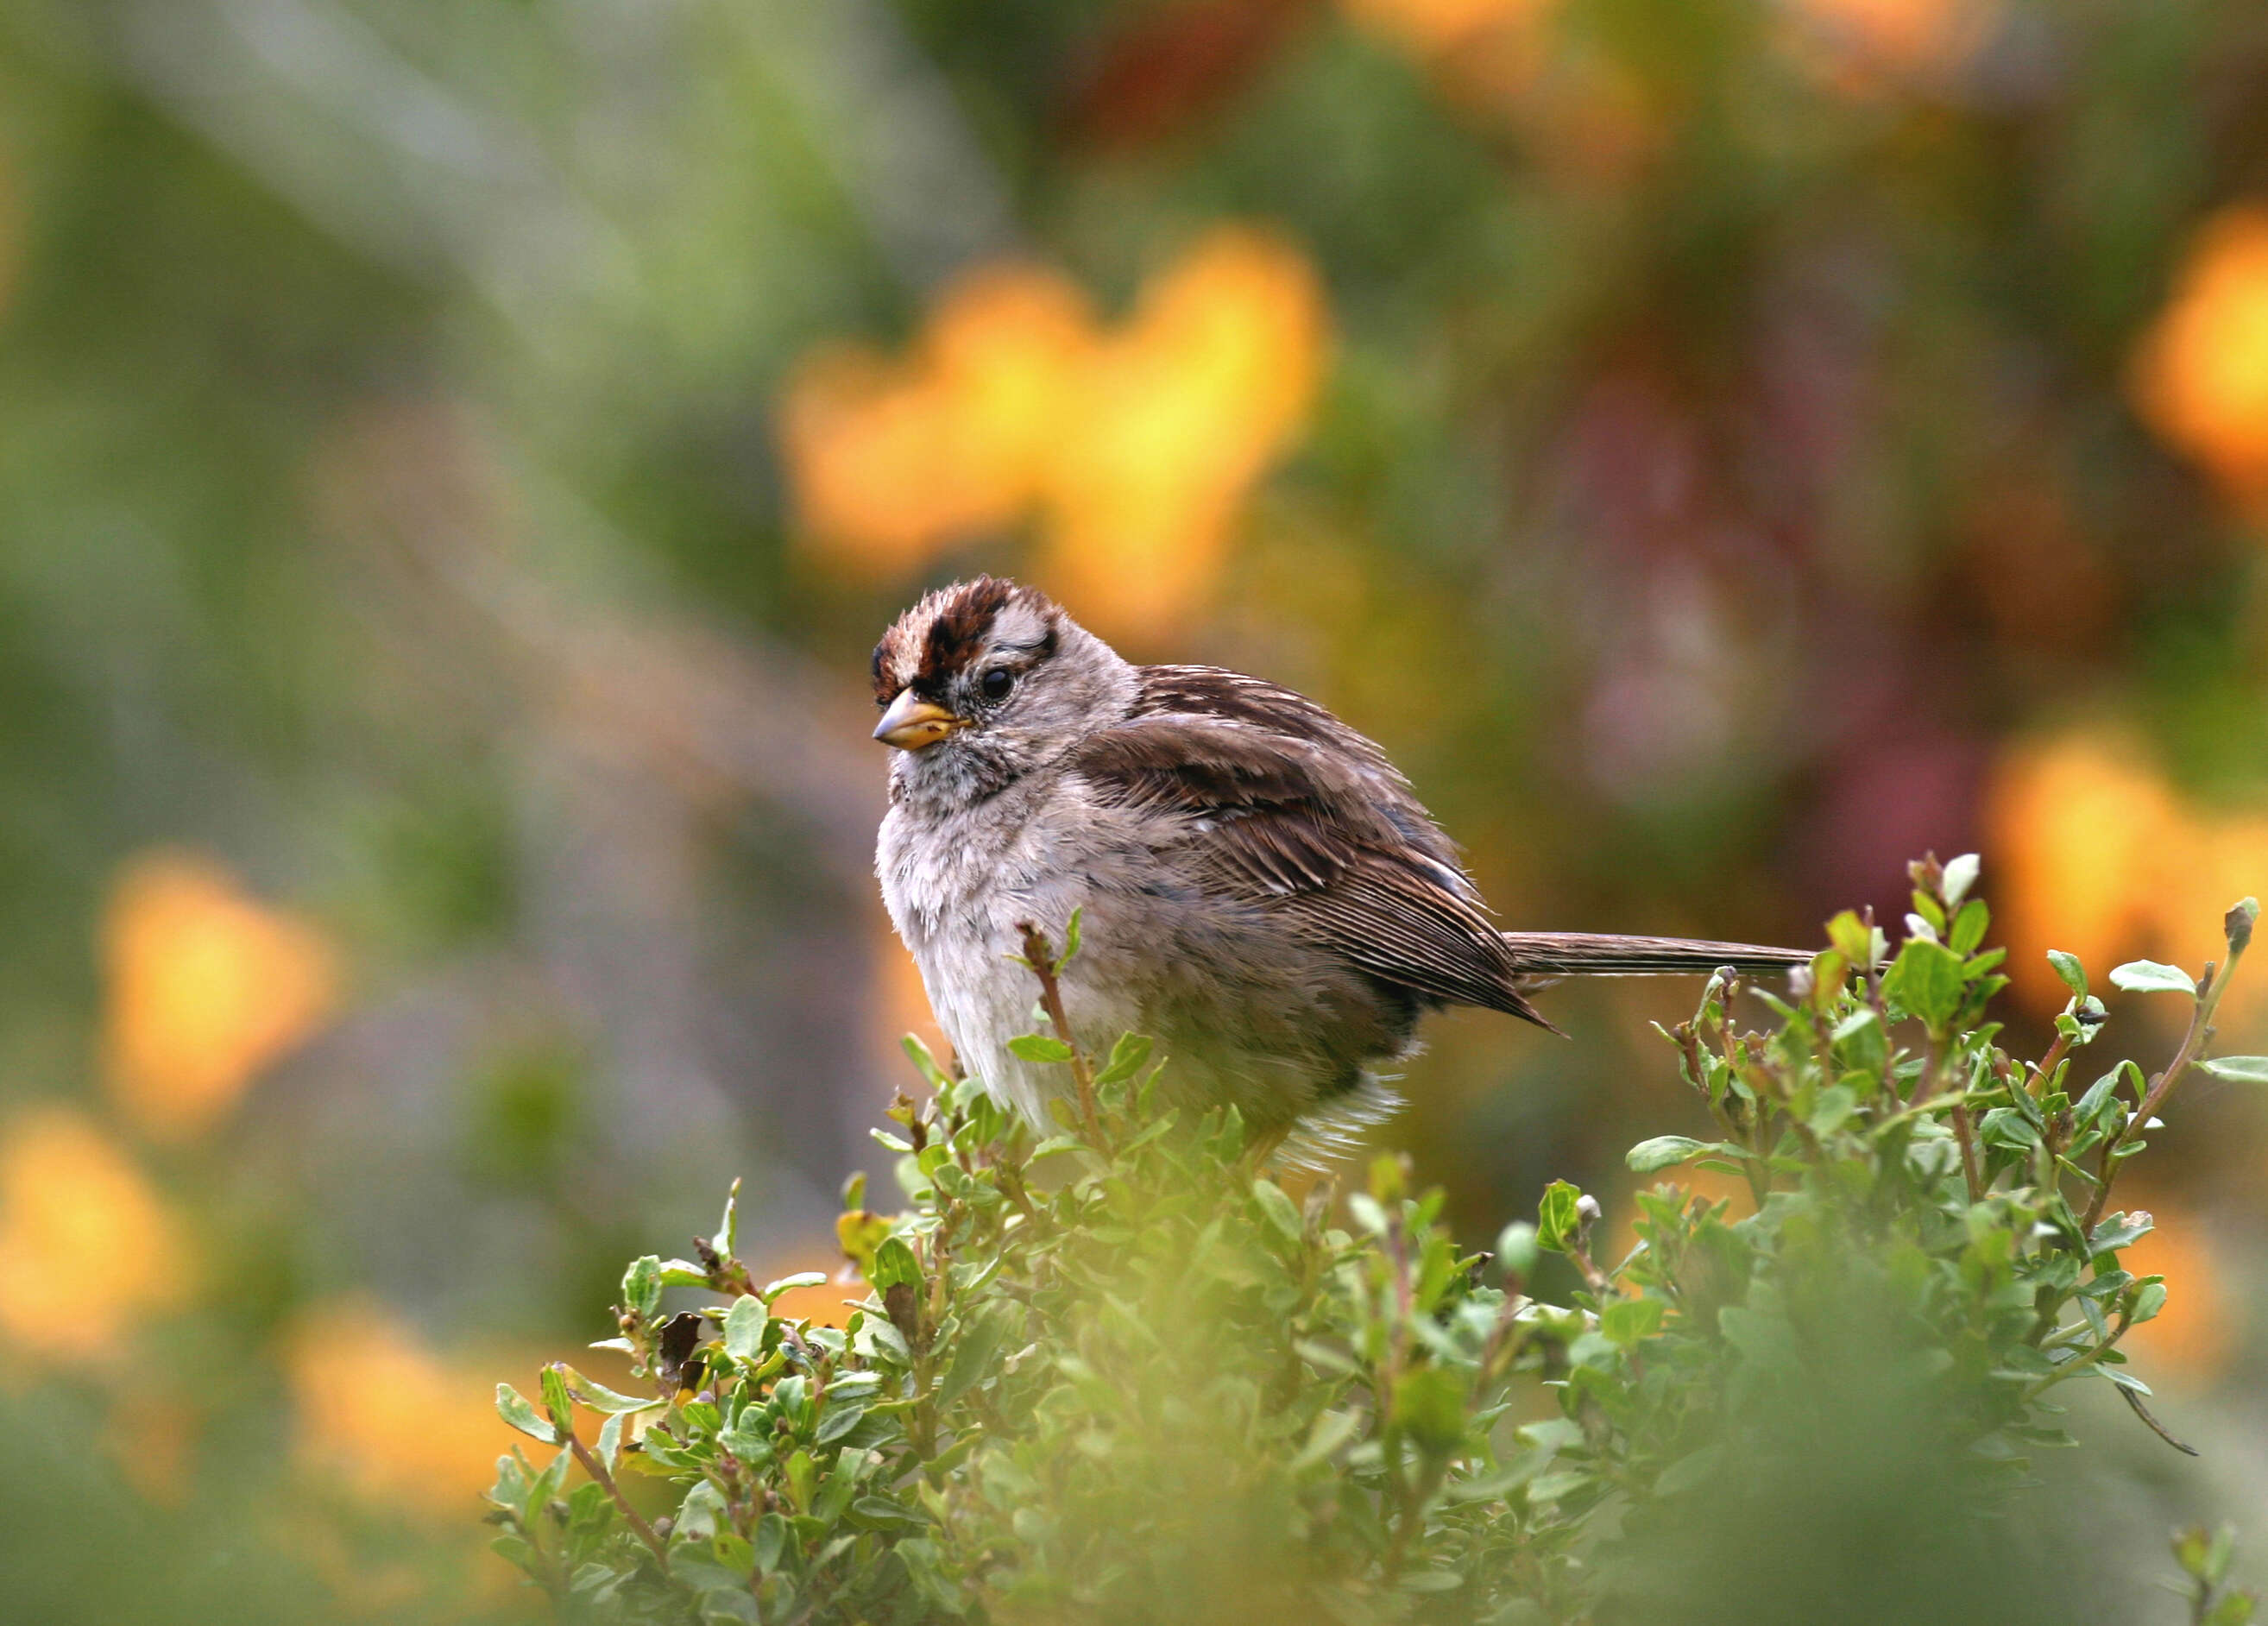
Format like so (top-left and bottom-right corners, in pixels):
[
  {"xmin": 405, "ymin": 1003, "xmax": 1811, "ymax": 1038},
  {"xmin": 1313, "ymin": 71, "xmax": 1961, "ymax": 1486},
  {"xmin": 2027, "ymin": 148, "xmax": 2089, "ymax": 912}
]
[{"xmin": 1073, "ymin": 667, "xmax": 1542, "ymax": 1023}]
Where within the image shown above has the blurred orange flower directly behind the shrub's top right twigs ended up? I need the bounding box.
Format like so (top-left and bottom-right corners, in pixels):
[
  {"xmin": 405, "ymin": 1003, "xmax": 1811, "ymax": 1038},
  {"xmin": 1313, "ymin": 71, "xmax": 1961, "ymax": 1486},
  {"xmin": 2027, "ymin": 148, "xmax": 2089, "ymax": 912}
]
[{"xmin": 1985, "ymin": 734, "xmax": 2268, "ymax": 1014}]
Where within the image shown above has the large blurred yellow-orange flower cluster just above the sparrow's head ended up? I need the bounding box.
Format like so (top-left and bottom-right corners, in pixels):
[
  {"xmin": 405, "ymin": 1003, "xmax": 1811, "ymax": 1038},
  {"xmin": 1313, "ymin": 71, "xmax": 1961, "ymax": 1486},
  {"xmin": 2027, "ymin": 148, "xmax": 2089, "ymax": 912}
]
[{"xmin": 780, "ymin": 227, "xmax": 1325, "ymax": 633}]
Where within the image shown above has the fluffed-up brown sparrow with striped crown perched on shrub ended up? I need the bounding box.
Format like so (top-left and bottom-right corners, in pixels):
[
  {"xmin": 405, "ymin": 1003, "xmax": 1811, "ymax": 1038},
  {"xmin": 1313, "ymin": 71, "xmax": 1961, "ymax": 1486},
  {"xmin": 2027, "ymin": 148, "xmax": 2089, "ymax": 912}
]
[{"xmin": 873, "ymin": 576, "xmax": 1810, "ymax": 1154}]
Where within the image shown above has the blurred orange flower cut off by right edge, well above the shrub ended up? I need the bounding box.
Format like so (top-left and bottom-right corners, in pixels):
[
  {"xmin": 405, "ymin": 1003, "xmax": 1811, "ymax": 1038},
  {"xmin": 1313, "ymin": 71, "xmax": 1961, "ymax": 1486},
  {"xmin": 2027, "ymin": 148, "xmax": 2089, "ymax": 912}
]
[{"xmin": 2134, "ymin": 204, "xmax": 2268, "ymax": 501}]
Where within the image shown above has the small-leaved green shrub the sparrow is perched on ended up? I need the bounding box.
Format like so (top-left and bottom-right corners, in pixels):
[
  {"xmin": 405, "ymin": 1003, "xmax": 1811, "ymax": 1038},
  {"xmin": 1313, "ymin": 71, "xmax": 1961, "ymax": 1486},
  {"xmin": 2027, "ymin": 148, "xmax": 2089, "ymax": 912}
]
[{"xmin": 490, "ymin": 860, "xmax": 2268, "ymax": 1626}]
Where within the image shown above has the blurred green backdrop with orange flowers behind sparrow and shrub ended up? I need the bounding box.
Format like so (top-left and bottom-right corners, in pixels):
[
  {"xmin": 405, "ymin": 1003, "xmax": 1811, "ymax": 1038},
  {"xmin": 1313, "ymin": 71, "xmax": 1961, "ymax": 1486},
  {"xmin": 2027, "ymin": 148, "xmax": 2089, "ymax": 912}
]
[{"xmin": 0, "ymin": 0, "xmax": 2268, "ymax": 1622}]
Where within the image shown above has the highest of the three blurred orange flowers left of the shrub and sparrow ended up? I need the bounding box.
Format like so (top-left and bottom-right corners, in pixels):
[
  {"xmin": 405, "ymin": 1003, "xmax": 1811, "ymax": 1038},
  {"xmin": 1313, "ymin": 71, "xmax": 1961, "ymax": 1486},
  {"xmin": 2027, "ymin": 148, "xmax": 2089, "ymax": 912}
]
[{"xmin": 102, "ymin": 853, "xmax": 338, "ymax": 1138}]
